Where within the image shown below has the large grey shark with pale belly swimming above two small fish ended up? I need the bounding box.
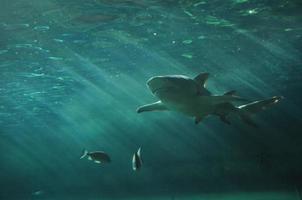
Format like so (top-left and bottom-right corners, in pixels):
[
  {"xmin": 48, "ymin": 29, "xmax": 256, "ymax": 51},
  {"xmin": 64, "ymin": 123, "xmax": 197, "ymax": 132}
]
[{"xmin": 137, "ymin": 73, "xmax": 283, "ymax": 127}]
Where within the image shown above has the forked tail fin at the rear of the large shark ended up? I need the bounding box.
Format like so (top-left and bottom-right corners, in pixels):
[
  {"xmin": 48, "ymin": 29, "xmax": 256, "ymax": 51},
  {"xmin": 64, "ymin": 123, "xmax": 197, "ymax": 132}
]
[{"xmin": 238, "ymin": 96, "xmax": 283, "ymax": 127}]
